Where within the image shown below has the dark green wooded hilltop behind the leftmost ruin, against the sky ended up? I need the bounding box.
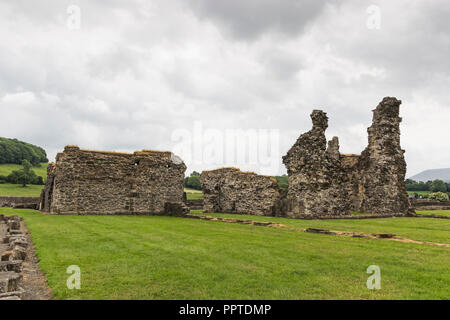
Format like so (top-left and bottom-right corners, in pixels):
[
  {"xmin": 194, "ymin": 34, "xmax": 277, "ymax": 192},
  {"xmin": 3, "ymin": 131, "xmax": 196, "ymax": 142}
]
[{"xmin": 0, "ymin": 137, "xmax": 48, "ymax": 165}]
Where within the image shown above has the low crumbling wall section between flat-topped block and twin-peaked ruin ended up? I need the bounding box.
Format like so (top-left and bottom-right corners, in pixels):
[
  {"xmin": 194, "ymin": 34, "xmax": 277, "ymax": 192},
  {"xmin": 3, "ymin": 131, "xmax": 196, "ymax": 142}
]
[{"xmin": 200, "ymin": 168, "xmax": 280, "ymax": 216}]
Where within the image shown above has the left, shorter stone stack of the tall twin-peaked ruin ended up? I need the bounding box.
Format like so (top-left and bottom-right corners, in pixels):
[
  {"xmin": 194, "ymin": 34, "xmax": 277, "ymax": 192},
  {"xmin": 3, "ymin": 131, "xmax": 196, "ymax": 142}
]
[{"xmin": 283, "ymin": 110, "xmax": 350, "ymax": 218}]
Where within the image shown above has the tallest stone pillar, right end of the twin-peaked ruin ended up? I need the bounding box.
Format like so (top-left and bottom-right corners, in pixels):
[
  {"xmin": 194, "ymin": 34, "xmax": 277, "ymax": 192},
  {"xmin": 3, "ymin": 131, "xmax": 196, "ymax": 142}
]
[{"xmin": 352, "ymin": 97, "xmax": 412, "ymax": 214}]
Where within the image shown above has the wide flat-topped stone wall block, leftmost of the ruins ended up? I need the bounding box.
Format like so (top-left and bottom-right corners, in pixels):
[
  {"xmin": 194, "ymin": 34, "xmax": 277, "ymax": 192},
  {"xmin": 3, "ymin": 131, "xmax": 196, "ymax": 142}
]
[{"xmin": 40, "ymin": 146, "xmax": 189, "ymax": 215}]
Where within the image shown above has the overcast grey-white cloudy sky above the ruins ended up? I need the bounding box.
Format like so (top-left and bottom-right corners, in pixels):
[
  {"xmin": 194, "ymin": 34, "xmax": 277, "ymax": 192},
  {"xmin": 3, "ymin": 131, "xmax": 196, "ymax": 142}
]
[{"xmin": 0, "ymin": 0, "xmax": 450, "ymax": 175}]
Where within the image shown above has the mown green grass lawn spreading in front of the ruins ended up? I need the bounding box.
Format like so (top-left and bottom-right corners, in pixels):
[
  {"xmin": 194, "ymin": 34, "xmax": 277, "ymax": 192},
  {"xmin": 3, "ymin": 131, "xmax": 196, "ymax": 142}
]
[{"xmin": 0, "ymin": 208, "xmax": 450, "ymax": 299}]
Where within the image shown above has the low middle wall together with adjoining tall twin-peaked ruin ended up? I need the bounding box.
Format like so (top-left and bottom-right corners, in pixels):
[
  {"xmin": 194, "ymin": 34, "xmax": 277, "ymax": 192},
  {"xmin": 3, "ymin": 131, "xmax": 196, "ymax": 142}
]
[{"xmin": 201, "ymin": 97, "xmax": 414, "ymax": 218}]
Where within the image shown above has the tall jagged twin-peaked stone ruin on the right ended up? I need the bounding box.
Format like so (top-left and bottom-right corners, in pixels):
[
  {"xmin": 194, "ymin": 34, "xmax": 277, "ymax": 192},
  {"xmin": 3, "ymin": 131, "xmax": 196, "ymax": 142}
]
[{"xmin": 283, "ymin": 97, "xmax": 413, "ymax": 217}]
